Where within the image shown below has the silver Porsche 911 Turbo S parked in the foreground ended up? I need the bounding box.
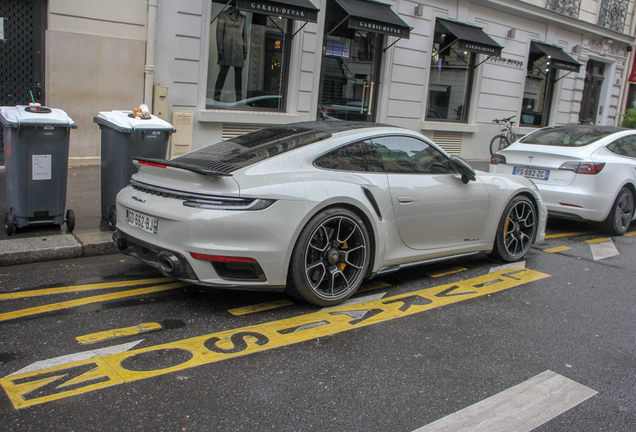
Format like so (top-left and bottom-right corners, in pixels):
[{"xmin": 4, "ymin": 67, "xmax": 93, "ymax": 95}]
[{"xmin": 114, "ymin": 122, "xmax": 547, "ymax": 306}]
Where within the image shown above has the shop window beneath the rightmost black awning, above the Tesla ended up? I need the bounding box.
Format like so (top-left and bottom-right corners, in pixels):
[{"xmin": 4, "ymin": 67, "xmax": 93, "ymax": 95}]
[{"xmin": 521, "ymin": 52, "xmax": 556, "ymax": 126}]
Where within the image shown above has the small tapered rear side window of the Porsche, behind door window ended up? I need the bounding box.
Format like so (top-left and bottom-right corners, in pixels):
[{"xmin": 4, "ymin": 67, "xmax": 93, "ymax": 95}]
[{"xmin": 314, "ymin": 141, "xmax": 384, "ymax": 172}]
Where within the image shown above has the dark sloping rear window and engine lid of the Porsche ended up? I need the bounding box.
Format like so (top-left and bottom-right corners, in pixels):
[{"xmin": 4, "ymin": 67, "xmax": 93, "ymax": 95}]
[{"xmin": 183, "ymin": 126, "xmax": 331, "ymax": 168}]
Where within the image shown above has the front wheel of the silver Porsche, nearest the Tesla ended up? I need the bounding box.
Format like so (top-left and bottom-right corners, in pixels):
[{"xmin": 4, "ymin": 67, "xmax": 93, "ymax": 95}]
[{"xmin": 492, "ymin": 196, "xmax": 537, "ymax": 262}]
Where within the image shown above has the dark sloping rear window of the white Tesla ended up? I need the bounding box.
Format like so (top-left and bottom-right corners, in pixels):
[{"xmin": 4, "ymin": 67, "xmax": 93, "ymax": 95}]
[{"xmin": 520, "ymin": 126, "xmax": 625, "ymax": 147}]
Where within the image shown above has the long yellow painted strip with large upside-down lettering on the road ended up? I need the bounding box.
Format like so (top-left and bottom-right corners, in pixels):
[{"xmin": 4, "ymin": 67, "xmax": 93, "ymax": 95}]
[{"xmin": 0, "ymin": 268, "xmax": 549, "ymax": 409}]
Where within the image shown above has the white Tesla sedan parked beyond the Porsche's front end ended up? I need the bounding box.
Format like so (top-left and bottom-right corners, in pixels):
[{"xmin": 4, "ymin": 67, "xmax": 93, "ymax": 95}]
[{"xmin": 490, "ymin": 125, "xmax": 636, "ymax": 235}]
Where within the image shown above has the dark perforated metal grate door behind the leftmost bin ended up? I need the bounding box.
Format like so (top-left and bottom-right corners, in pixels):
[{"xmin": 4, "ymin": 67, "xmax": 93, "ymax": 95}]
[{"xmin": 0, "ymin": 0, "xmax": 47, "ymax": 165}]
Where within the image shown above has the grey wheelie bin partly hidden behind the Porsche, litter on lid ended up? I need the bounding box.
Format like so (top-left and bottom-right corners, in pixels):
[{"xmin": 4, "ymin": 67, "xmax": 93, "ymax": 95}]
[{"xmin": 93, "ymin": 111, "xmax": 176, "ymax": 230}]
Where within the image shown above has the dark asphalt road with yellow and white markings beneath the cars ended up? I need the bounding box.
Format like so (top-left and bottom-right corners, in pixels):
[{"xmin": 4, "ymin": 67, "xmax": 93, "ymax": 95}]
[{"xmin": 0, "ymin": 219, "xmax": 636, "ymax": 432}]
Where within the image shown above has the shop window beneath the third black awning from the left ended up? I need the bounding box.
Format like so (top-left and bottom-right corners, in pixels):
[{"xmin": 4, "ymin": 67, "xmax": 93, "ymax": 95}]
[{"xmin": 426, "ymin": 22, "xmax": 476, "ymax": 122}]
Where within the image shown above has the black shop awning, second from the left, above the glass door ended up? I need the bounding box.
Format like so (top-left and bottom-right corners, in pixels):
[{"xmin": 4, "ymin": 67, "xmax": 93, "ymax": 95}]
[{"xmin": 336, "ymin": 0, "xmax": 411, "ymax": 39}]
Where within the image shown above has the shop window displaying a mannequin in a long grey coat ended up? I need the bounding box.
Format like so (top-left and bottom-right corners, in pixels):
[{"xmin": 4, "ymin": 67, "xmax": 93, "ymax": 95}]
[{"xmin": 206, "ymin": 1, "xmax": 293, "ymax": 110}]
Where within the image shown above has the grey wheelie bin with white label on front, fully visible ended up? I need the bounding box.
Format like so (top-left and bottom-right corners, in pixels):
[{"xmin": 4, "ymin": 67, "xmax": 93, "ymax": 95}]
[{"xmin": 0, "ymin": 104, "xmax": 77, "ymax": 235}]
